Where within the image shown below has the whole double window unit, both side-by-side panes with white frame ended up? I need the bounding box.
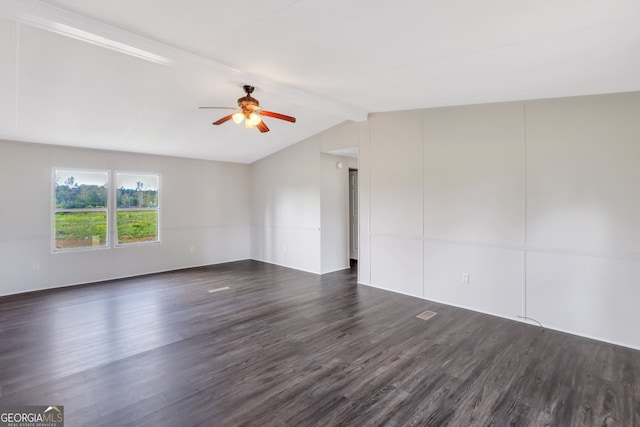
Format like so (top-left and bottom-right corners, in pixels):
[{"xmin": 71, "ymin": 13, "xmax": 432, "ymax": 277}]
[{"xmin": 53, "ymin": 169, "xmax": 160, "ymax": 251}]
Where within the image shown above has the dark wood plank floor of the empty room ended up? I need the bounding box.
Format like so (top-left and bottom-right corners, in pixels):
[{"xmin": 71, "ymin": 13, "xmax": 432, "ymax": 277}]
[{"xmin": 0, "ymin": 261, "xmax": 640, "ymax": 427}]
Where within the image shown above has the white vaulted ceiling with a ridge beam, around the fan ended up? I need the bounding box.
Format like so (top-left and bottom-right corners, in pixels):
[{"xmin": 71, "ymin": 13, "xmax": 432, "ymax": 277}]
[{"xmin": 0, "ymin": 0, "xmax": 640, "ymax": 163}]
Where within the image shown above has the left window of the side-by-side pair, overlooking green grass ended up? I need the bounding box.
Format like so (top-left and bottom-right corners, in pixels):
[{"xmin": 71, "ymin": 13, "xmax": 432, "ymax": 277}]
[{"xmin": 53, "ymin": 169, "xmax": 109, "ymax": 250}]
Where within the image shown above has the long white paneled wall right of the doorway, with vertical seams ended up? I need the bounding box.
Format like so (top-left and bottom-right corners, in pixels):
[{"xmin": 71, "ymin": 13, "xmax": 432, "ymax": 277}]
[{"xmin": 359, "ymin": 93, "xmax": 640, "ymax": 348}]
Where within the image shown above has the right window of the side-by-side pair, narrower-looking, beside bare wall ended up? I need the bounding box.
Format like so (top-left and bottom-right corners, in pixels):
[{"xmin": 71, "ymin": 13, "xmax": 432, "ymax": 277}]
[{"xmin": 116, "ymin": 172, "xmax": 159, "ymax": 245}]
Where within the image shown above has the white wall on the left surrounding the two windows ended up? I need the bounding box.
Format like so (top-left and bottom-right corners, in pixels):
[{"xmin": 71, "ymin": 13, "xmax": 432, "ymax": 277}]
[{"xmin": 0, "ymin": 141, "xmax": 250, "ymax": 295}]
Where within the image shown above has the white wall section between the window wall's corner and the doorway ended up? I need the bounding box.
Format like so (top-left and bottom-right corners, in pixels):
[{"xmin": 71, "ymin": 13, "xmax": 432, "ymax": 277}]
[{"xmin": 251, "ymin": 122, "xmax": 362, "ymax": 274}]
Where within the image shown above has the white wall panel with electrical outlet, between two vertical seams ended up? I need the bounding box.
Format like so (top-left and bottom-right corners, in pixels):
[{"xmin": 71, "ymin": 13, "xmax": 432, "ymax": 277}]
[{"xmin": 422, "ymin": 104, "xmax": 525, "ymax": 318}]
